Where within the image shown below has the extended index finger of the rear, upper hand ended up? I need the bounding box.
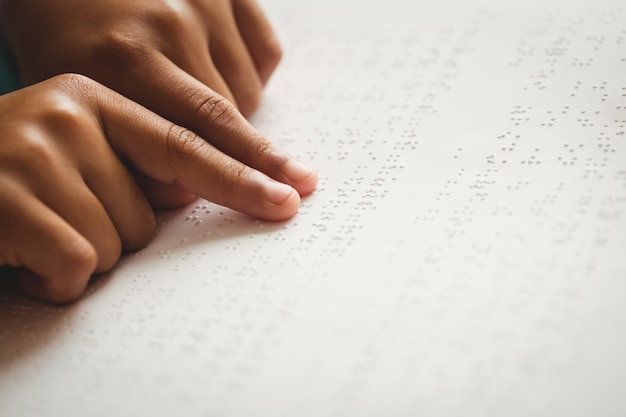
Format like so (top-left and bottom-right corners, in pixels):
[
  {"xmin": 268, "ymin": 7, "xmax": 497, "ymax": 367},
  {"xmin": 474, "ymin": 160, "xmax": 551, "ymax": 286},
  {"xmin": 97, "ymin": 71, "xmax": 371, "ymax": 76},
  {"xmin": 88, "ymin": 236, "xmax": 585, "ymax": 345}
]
[{"xmin": 103, "ymin": 58, "xmax": 317, "ymax": 200}]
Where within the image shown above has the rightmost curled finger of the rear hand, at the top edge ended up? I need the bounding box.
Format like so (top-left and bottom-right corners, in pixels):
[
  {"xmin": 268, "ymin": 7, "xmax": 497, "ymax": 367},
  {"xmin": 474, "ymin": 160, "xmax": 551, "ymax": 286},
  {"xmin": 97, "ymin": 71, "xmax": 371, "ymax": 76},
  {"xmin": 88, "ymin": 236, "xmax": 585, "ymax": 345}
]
[{"xmin": 233, "ymin": 0, "xmax": 283, "ymax": 85}]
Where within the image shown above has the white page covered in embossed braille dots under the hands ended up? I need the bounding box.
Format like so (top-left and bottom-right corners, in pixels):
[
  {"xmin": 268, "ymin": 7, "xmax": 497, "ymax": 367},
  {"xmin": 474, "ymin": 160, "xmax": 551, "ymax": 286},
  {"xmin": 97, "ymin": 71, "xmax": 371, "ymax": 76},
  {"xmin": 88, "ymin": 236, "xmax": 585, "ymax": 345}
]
[{"xmin": 0, "ymin": 0, "xmax": 626, "ymax": 417}]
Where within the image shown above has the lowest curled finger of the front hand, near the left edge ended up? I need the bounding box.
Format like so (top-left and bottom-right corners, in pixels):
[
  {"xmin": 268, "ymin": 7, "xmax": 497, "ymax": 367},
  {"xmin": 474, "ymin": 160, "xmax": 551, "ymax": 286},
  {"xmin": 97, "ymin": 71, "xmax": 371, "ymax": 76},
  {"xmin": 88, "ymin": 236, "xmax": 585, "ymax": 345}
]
[{"xmin": 0, "ymin": 190, "xmax": 98, "ymax": 303}]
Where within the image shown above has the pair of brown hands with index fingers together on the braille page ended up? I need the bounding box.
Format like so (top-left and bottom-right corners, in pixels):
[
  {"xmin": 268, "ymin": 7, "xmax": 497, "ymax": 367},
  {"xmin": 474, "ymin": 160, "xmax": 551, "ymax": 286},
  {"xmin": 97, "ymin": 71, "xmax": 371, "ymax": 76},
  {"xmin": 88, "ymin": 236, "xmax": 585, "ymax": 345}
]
[{"xmin": 0, "ymin": 0, "xmax": 317, "ymax": 303}]
